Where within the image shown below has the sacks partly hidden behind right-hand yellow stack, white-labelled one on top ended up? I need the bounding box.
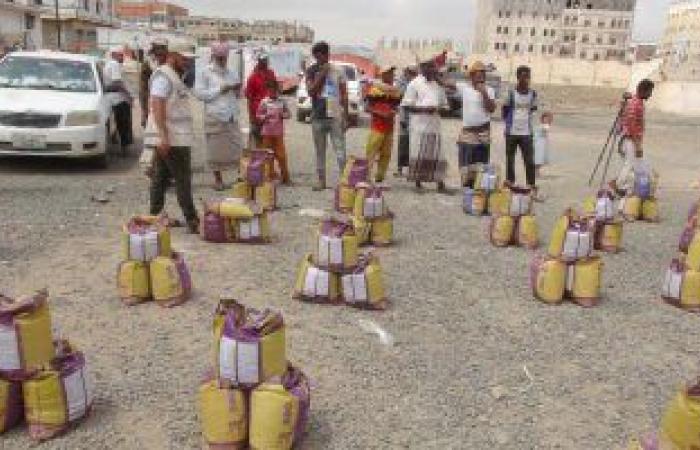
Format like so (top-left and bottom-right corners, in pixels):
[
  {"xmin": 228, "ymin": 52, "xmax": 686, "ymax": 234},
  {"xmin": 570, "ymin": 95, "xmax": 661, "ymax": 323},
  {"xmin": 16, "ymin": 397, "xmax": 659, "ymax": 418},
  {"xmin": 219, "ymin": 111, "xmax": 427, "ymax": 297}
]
[{"xmin": 583, "ymin": 189, "xmax": 623, "ymax": 253}]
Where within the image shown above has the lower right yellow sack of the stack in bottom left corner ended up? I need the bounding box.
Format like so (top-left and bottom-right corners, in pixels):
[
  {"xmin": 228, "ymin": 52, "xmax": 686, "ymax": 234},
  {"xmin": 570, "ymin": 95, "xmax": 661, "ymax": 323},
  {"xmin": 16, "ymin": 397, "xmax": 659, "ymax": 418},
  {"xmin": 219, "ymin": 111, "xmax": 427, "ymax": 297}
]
[{"xmin": 22, "ymin": 341, "xmax": 93, "ymax": 441}]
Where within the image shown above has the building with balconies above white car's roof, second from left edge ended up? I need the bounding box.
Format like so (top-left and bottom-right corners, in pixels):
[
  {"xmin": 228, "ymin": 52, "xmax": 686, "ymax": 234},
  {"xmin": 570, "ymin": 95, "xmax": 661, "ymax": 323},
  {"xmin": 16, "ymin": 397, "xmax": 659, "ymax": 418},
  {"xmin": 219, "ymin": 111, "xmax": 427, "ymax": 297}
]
[{"xmin": 38, "ymin": 0, "xmax": 116, "ymax": 53}]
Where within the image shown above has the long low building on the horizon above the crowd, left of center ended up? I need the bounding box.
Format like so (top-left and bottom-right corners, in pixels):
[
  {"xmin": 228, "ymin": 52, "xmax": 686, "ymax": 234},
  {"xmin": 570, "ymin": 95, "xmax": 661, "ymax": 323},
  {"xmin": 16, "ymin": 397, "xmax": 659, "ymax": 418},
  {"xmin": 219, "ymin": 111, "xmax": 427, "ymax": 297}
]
[{"xmin": 176, "ymin": 16, "xmax": 314, "ymax": 45}]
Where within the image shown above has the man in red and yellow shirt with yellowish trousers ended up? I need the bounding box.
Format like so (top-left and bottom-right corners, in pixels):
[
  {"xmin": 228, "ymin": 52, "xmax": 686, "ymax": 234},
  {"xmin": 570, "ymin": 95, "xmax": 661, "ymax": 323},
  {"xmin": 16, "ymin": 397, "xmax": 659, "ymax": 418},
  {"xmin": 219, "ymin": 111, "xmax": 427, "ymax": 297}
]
[{"xmin": 366, "ymin": 66, "xmax": 401, "ymax": 183}]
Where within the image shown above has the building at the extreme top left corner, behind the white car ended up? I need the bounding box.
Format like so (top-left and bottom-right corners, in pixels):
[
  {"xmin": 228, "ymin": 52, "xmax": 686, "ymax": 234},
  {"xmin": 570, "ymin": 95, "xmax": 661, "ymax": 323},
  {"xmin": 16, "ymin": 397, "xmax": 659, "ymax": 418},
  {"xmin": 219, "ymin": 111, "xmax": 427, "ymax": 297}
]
[{"xmin": 0, "ymin": 0, "xmax": 42, "ymax": 50}]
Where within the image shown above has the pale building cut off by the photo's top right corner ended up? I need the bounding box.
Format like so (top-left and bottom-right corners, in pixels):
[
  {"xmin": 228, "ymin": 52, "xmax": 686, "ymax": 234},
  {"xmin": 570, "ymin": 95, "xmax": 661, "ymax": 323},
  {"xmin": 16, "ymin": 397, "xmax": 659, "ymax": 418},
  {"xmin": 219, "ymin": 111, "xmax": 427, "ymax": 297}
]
[{"xmin": 661, "ymin": 0, "xmax": 700, "ymax": 81}]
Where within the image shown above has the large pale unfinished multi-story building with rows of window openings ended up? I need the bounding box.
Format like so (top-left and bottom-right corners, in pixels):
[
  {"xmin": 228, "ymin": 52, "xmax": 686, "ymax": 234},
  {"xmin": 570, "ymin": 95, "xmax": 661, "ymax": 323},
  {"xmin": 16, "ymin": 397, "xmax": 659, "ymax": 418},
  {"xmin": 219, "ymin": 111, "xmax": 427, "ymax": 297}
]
[{"xmin": 474, "ymin": 0, "xmax": 636, "ymax": 61}]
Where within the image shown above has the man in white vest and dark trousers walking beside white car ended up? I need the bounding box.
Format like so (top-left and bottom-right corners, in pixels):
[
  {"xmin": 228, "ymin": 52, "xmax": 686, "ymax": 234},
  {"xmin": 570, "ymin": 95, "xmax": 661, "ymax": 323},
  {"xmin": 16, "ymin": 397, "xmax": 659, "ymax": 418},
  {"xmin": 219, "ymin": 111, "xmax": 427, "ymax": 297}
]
[{"xmin": 144, "ymin": 44, "xmax": 199, "ymax": 233}]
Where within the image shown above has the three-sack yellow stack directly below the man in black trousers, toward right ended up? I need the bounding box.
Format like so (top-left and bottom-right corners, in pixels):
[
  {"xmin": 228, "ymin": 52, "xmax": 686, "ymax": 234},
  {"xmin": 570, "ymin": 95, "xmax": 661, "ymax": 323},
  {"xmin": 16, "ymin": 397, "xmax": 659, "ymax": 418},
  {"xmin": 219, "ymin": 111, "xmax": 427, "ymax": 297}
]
[{"xmin": 530, "ymin": 209, "xmax": 602, "ymax": 307}]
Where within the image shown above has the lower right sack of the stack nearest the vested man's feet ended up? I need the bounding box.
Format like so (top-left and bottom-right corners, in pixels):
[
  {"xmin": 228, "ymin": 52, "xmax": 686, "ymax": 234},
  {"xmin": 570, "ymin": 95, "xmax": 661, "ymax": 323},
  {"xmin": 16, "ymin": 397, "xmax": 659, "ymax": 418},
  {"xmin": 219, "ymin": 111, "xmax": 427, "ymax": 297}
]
[{"xmin": 150, "ymin": 252, "xmax": 192, "ymax": 308}]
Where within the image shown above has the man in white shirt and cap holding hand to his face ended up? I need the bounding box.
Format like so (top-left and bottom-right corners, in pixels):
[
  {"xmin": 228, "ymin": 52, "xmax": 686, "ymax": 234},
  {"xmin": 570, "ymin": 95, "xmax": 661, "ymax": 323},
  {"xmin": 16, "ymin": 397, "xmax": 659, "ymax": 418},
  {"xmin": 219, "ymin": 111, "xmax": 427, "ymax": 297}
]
[{"xmin": 457, "ymin": 61, "xmax": 496, "ymax": 187}]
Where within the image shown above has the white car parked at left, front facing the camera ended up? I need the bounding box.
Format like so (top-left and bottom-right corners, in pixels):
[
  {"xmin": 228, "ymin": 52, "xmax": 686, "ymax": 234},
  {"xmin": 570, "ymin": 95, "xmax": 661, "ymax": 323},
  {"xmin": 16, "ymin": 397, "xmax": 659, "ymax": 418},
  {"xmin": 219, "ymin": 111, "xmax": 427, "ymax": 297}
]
[{"xmin": 0, "ymin": 51, "xmax": 114, "ymax": 166}]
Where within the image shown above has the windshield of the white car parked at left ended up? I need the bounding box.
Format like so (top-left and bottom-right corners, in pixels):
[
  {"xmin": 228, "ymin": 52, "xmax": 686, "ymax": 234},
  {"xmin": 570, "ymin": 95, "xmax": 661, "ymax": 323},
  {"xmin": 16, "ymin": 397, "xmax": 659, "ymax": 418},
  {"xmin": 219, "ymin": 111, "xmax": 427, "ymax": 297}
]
[{"xmin": 0, "ymin": 56, "xmax": 97, "ymax": 92}]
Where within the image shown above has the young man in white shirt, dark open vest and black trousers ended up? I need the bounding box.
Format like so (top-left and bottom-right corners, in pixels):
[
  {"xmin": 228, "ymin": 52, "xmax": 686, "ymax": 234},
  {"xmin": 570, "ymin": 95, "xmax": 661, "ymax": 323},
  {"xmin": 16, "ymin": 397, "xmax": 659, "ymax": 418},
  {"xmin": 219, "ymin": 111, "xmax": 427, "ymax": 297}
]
[{"xmin": 503, "ymin": 66, "xmax": 538, "ymax": 199}]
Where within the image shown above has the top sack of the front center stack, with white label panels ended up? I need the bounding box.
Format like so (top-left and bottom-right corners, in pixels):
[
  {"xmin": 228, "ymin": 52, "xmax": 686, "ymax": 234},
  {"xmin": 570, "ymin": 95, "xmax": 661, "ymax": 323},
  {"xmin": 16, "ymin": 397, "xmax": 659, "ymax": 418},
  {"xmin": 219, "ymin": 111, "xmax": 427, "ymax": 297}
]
[{"xmin": 214, "ymin": 298, "xmax": 287, "ymax": 387}]
